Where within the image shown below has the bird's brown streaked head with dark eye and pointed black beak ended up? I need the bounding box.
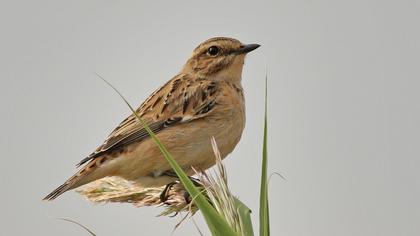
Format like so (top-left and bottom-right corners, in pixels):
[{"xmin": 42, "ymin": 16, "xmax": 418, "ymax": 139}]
[{"xmin": 182, "ymin": 37, "xmax": 260, "ymax": 81}]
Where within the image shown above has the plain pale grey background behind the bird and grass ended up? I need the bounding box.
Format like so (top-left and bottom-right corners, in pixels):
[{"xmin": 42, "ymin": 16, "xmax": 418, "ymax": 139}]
[{"xmin": 0, "ymin": 0, "xmax": 420, "ymax": 236}]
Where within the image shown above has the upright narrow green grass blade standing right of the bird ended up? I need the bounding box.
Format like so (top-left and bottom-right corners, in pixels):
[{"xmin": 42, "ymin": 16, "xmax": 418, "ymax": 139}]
[{"xmin": 260, "ymin": 76, "xmax": 270, "ymax": 236}]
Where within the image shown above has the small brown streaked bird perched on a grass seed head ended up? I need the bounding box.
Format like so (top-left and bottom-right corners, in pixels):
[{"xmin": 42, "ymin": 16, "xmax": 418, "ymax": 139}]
[{"xmin": 43, "ymin": 37, "xmax": 260, "ymax": 201}]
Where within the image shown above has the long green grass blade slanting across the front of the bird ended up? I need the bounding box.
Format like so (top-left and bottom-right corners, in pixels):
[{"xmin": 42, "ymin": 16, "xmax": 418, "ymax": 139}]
[{"xmin": 96, "ymin": 74, "xmax": 237, "ymax": 236}]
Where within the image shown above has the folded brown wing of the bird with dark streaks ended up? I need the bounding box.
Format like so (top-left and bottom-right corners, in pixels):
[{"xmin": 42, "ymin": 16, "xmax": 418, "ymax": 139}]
[{"xmin": 77, "ymin": 74, "xmax": 219, "ymax": 166}]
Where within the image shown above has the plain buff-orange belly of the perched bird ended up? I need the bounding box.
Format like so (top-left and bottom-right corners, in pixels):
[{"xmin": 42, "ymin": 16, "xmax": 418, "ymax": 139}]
[{"xmin": 110, "ymin": 106, "xmax": 245, "ymax": 185}]
